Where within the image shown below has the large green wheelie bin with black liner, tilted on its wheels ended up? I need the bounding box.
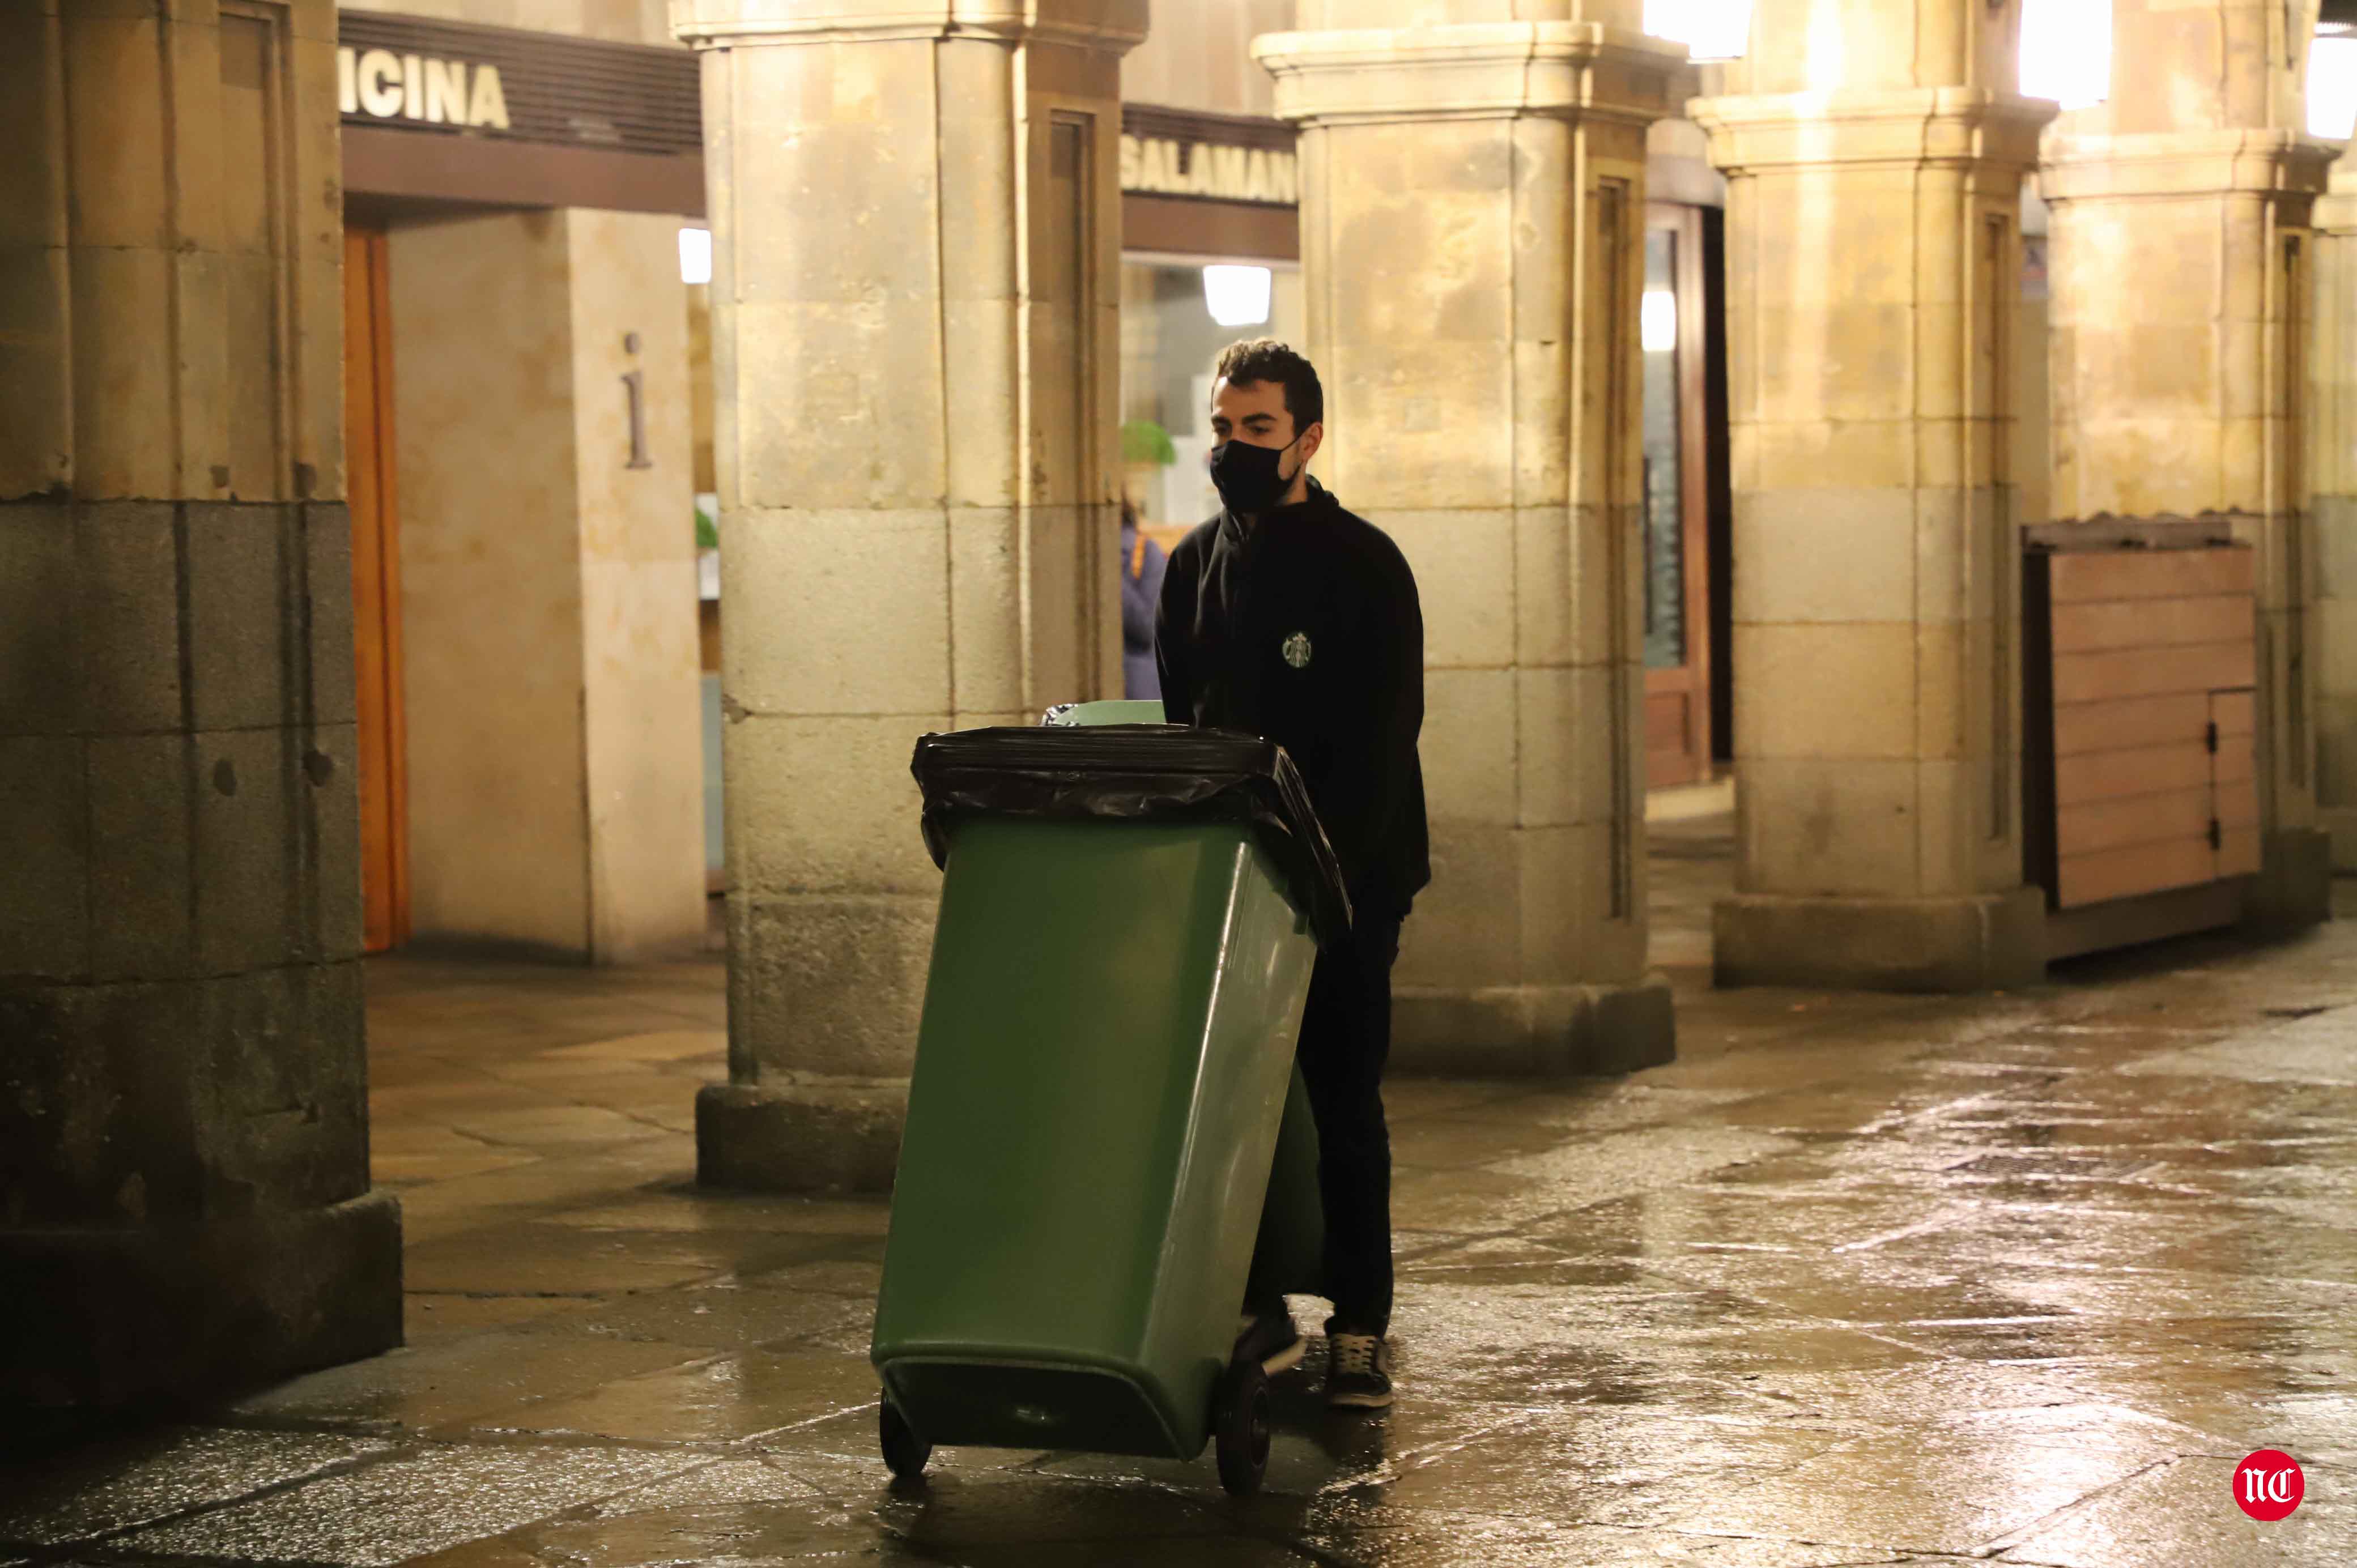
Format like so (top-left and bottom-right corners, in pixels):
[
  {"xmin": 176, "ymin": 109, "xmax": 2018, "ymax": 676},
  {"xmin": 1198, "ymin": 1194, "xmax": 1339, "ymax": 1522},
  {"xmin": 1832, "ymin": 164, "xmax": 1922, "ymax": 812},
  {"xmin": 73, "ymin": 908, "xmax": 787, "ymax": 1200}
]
[{"xmin": 872, "ymin": 705, "xmax": 1348, "ymax": 1493}]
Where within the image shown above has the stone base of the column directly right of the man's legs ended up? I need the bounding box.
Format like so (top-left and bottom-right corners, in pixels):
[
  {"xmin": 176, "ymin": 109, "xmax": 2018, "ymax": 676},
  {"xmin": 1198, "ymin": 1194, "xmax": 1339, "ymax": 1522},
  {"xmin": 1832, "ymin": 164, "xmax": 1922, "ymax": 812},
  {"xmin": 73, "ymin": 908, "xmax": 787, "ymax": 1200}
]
[{"xmin": 1390, "ymin": 976, "xmax": 1678, "ymax": 1077}]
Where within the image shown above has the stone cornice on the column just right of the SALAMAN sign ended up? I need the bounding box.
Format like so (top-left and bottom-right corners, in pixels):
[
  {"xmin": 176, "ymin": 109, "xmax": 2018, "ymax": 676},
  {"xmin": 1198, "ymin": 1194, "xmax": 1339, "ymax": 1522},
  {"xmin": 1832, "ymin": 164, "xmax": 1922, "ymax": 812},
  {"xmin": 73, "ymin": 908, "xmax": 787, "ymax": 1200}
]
[{"xmin": 1252, "ymin": 21, "xmax": 1685, "ymax": 127}]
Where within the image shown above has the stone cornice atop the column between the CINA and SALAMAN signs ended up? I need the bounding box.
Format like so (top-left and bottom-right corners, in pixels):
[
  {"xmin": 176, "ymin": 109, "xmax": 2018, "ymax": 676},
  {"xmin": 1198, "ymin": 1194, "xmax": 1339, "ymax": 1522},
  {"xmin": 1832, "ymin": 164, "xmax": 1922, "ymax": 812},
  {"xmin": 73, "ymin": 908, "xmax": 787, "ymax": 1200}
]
[{"xmin": 672, "ymin": 0, "xmax": 1148, "ymax": 52}]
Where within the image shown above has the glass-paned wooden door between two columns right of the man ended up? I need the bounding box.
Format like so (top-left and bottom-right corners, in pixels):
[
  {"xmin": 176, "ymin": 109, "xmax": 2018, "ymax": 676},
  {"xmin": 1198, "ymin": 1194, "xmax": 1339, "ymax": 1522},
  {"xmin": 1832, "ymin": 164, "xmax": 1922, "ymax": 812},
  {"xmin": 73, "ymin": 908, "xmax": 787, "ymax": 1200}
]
[{"xmin": 1638, "ymin": 203, "xmax": 1711, "ymax": 790}]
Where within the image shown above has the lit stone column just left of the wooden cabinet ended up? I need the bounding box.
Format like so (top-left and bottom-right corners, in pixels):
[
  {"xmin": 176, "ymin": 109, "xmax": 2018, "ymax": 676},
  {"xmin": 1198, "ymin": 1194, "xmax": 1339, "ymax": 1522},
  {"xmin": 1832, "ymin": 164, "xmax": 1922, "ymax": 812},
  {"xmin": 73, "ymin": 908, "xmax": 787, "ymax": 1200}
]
[{"xmin": 1688, "ymin": 0, "xmax": 2053, "ymax": 990}]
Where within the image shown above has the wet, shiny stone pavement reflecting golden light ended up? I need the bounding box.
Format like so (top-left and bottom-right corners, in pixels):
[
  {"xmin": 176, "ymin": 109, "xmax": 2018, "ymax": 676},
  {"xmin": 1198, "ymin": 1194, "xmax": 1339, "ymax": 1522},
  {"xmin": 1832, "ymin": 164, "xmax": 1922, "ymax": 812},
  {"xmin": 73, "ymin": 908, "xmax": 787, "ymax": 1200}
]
[{"xmin": 0, "ymin": 825, "xmax": 2357, "ymax": 1568}]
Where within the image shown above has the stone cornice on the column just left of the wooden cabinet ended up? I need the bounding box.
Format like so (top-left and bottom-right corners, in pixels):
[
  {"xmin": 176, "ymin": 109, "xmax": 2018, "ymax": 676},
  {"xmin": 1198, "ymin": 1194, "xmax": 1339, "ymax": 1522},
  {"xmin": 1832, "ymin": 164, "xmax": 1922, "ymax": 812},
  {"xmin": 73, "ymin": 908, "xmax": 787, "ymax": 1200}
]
[{"xmin": 1685, "ymin": 87, "xmax": 2056, "ymax": 177}]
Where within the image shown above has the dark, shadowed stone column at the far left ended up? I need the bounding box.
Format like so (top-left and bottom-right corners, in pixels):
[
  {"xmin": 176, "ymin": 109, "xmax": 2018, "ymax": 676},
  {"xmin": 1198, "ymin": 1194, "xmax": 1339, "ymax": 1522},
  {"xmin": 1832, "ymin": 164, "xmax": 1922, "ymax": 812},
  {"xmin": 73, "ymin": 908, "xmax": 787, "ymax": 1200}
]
[{"xmin": 0, "ymin": 0, "xmax": 401, "ymax": 1403}]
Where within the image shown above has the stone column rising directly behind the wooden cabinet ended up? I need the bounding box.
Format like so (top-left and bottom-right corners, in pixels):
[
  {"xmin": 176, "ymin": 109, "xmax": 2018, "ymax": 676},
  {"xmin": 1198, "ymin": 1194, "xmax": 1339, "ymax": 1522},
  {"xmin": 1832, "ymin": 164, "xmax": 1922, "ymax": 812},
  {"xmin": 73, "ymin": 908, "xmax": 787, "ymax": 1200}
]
[{"xmin": 2039, "ymin": 0, "xmax": 2331, "ymax": 927}]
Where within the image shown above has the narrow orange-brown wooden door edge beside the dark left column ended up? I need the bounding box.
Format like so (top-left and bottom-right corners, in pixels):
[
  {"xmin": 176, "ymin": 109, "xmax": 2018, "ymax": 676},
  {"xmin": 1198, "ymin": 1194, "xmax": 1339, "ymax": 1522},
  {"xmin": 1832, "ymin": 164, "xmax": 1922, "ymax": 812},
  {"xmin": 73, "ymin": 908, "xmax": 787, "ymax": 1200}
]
[{"xmin": 344, "ymin": 229, "xmax": 410, "ymax": 953}]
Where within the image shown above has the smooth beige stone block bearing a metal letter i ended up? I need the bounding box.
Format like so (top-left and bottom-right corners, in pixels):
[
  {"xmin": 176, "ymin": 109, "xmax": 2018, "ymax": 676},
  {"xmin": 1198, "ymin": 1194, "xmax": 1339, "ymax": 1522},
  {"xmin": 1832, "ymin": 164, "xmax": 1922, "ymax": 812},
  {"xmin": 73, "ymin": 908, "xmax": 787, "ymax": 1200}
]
[{"xmin": 386, "ymin": 210, "xmax": 705, "ymax": 964}]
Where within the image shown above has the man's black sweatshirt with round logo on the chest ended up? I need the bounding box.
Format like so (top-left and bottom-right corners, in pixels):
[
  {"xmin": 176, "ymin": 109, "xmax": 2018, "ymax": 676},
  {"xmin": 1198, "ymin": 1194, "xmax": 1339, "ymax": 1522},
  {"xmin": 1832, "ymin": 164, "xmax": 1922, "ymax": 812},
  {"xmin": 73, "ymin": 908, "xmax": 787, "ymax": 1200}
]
[{"xmin": 1155, "ymin": 479, "xmax": 1433, "ymax": 917}]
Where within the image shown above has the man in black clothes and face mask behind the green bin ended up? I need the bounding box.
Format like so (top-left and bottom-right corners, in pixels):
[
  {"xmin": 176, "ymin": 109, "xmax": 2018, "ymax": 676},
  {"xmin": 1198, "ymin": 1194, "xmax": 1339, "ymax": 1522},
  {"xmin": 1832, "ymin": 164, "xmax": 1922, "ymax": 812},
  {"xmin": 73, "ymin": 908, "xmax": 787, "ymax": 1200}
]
[{"xmin": 1155, "ymin": 337, "xmax": 1431, "ymax": 1408}]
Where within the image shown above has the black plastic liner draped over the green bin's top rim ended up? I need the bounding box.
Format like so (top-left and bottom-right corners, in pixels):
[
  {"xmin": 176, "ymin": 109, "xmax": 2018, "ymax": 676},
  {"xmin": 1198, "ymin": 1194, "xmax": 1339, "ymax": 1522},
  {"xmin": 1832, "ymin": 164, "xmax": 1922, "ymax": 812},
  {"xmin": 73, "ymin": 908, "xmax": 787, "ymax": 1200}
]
[{"xmin": 910, "ymin": 724, "xmax": 1351, "ymax": 948}]
